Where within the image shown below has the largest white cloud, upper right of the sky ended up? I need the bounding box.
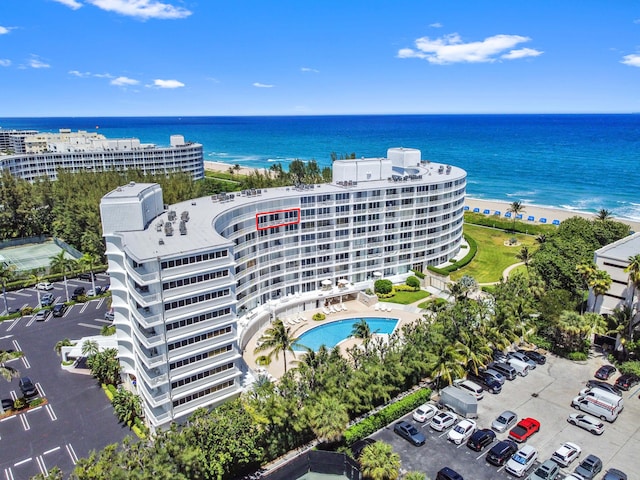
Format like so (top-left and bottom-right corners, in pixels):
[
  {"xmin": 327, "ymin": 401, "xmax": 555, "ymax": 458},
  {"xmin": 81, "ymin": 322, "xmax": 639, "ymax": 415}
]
[{"xmin": 398, "ymin": 33, "xmax": 542, "ymax": 65}]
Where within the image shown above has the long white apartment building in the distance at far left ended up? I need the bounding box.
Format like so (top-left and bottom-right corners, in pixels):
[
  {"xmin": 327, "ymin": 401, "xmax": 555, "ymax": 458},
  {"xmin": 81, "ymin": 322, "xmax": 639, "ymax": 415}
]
[{"xmin": 0, "ymin": 129, "xmax": 204, "ymax": 182}]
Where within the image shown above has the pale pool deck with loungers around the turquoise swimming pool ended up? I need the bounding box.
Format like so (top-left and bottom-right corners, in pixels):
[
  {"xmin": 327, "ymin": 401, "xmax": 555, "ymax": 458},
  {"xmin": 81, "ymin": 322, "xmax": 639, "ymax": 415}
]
[{"xmin": 243, "ymin": 299, "xmax": 425, "ymax": 379}]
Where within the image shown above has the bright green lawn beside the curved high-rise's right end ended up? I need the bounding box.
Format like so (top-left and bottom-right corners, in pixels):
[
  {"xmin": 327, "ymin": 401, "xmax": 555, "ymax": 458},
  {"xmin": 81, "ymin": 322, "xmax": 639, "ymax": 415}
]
[{"xmin": 451, "ymin": 223, "xmax": 537, "ymax": 283}]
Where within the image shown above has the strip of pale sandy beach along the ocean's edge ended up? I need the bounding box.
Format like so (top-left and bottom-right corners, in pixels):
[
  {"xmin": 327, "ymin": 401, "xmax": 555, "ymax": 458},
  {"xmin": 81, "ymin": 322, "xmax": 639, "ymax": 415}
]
[{"xmin": 204, "ymin": 160, "xmax": 640, "ymax": 232}]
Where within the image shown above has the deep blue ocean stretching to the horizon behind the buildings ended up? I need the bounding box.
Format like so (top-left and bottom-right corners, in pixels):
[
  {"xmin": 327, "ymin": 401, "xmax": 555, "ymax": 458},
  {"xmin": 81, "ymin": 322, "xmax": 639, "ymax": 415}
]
[{"xmin": 0, "ymin": 114, "xmax": 640, "ymax": 220}]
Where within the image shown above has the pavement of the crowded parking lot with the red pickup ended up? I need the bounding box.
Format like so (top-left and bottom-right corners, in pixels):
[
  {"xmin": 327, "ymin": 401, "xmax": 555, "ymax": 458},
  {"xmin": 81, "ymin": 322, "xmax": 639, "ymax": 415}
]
[{"xmin": 373, "ymin": 355, "xmax": 640, "ymax": 480}]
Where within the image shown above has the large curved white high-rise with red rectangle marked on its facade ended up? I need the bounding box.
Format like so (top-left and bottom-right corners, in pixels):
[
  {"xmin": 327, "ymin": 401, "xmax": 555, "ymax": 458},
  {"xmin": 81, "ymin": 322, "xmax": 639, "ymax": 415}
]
[{"xmin": 100, "ymin": 148, "xmax": 466, "ymax": 427}]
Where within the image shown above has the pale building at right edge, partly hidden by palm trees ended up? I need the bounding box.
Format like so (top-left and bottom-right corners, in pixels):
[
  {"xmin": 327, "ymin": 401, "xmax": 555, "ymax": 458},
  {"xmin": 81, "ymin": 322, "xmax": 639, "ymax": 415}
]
[{"xmin": 587, "ymin": 233, "xmax": 640, "ymax": 315}]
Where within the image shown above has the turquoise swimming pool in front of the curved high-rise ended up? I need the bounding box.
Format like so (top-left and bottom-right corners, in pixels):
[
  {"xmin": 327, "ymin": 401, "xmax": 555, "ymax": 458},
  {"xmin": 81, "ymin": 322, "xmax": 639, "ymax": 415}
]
[{"xmin": 295, "ymin": 317, "xmax": 398, "ymax": 351}]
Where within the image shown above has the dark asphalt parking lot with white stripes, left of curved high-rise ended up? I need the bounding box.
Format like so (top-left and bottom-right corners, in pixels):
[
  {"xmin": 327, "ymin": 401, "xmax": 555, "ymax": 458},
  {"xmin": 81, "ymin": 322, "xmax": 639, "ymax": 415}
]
[{"xmin": 0, "ymin": 276, "xmax": 131, "ymax": 480}]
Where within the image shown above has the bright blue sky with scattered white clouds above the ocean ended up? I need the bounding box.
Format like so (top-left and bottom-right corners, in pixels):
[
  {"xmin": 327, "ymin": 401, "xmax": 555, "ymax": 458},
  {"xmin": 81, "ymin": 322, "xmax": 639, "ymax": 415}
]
[{"xmin": 0, "ymin": 0, "xmax": 640, "ymax": 117}]
